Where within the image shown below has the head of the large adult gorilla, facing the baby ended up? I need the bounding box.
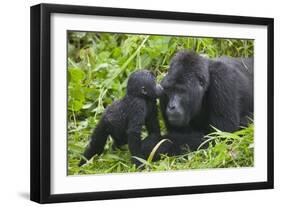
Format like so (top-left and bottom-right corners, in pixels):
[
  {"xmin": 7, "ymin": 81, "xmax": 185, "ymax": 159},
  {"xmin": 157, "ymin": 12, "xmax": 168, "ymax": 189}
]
[{"xmin": 161, "ymin": 51, "xmax": 209, "ymax": 127}]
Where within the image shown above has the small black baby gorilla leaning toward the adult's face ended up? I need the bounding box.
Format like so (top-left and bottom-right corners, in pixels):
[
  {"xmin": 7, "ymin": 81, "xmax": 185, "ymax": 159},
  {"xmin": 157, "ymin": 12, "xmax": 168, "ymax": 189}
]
[{"xmin": 79, "ymin": 70, "xmax": 162, "ymax": 166}]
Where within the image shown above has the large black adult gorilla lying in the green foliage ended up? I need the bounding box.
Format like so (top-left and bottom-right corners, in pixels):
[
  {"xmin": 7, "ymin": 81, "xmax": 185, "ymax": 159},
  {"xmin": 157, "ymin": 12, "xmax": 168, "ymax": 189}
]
[{"xmin": 143, "ymin": 51, "xmax": 253, "ymax": 158}]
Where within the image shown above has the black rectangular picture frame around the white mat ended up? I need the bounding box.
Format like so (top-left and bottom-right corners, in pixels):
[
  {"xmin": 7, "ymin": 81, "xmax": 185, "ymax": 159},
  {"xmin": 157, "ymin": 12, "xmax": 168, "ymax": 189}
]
[{"xmin": 30, "ymin": 4, "xmax": 274, "ymax": 203}]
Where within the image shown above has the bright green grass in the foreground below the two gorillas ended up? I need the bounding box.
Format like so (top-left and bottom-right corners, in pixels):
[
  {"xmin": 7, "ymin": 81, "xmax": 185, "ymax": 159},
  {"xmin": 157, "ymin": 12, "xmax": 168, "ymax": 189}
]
[{"xmin": 69, "ymin": 124, "xmax": 254, "ymax": 175}]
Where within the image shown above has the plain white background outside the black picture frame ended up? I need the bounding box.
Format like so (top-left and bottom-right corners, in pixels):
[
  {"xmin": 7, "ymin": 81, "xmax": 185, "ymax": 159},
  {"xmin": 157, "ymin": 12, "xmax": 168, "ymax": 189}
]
[{"xmin": 0, "ymin": 0, "xmax": 281, "ymax": 207}]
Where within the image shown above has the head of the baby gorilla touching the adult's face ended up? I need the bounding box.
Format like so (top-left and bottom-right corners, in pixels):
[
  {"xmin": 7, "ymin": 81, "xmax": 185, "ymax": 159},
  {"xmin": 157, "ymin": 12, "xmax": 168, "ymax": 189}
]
[{"xmin": 127, "ymin": 70, "xmax": 162, "ymax": 99}]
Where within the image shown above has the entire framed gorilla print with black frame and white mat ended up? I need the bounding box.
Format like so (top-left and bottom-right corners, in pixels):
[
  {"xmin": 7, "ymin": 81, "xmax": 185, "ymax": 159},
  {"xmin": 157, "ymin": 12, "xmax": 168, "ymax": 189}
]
[{"xmin": 30, "ymin": 4, "xmax": 274, "ymax": 203}]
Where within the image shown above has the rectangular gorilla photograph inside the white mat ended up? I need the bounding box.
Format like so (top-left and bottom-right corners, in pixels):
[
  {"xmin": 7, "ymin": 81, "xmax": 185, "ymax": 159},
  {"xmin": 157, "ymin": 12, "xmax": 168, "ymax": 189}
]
[{"xmin": 66, "ymin": 30, "xmax": 255, "ymax": 176}]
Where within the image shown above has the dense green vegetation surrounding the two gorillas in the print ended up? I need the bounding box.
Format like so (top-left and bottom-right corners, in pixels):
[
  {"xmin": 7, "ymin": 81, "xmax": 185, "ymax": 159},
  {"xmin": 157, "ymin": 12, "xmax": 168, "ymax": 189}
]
[{"xmin": 68, "ymin": 32, "xmax": 254, "ymax": 175}]
